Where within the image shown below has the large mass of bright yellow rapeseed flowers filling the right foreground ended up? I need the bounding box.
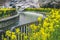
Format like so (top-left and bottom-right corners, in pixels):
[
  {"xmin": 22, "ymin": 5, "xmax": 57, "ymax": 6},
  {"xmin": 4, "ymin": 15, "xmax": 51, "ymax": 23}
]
[{"xmin": 1, "ymin": 8, "xmax": 60, "ymax": 40}]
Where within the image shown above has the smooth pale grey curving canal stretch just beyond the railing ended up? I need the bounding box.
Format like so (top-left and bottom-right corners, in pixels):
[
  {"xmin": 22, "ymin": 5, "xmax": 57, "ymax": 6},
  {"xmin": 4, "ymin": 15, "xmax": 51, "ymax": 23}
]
[{"xmin": 19, "ymin": 12, "xmax": 43, "ymax": 25}]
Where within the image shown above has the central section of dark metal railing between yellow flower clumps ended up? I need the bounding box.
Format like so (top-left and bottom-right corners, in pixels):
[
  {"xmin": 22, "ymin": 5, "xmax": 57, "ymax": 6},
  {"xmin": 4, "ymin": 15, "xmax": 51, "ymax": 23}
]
[{"xmin": 11, "ymin": 21, "xmax": 38, "ymax": 40}]
